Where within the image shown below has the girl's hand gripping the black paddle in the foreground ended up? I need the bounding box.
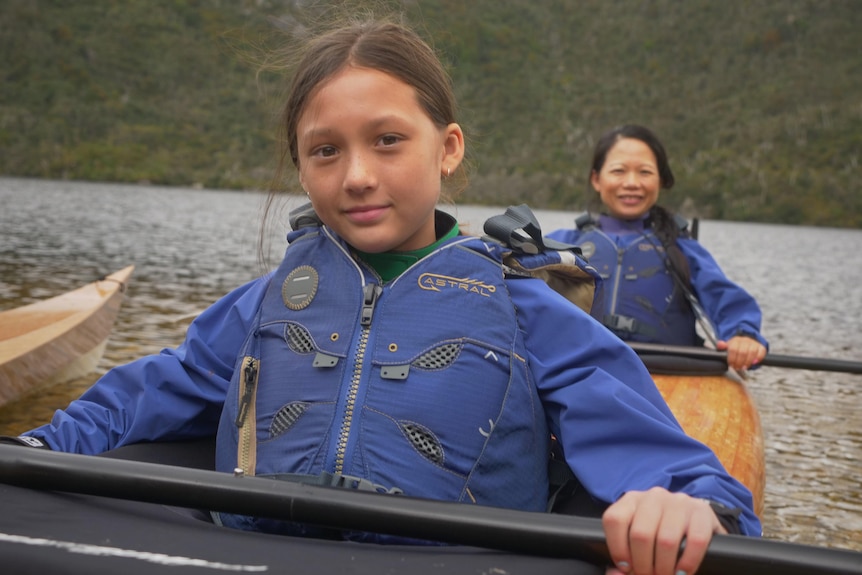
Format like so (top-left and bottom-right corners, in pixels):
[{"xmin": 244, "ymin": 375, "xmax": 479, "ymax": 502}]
[{"xmin": 602, "ymin": 487, "xmax": 727, "ymax": 575}]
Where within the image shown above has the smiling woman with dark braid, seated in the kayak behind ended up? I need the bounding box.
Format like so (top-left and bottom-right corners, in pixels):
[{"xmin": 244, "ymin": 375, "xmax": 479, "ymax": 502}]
[{"xmin": 549, "ymin": 125, "xmax": 768, "ymax": 370}]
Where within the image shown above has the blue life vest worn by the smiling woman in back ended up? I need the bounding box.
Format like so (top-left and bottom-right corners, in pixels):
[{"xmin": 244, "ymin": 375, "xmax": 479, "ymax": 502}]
[{"xmin": 577, "ymin": 217, "xmax": 702, "ymax": 346}]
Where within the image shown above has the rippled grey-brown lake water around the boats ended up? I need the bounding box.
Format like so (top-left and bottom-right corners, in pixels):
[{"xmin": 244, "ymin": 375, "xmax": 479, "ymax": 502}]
[{"xmin": 0, "ymin": 178, "xmax": 862, "ymax": 550}]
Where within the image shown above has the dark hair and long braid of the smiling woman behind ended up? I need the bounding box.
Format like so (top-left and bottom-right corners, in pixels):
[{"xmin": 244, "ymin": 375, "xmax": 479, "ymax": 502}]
[{"xmin": 590, "ymin": 124, "xmax": 691, "ymax": 286}]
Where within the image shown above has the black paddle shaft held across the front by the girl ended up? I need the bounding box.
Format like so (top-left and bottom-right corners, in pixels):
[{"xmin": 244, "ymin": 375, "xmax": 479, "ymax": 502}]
[{"xmin": 0, "ymin": 445, "xmax": 862, "ymax": 575}]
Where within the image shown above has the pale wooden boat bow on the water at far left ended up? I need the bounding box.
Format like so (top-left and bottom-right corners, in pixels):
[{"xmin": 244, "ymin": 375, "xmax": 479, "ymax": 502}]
[{"xmin": 0, "ymin": 266, "xmax": 134, "ymax": 405}]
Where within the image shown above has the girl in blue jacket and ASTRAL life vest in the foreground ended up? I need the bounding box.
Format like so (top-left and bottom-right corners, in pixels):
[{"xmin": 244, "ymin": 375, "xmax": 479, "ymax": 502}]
[{"xmin": 10, "ymin": 18, "xmax": 760, "ymax": 574}]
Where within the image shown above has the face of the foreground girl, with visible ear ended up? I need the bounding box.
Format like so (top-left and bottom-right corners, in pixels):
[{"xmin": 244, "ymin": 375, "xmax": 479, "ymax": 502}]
[{"xmin": 296, "ymin": 66, "xmax": 464, "ymax": 253}]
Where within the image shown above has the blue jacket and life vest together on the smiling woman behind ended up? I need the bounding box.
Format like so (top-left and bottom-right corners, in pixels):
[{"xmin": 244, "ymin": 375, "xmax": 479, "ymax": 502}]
[{"xmin": 548, "ymin": 213, "xmax": 768, "ymax": 346}]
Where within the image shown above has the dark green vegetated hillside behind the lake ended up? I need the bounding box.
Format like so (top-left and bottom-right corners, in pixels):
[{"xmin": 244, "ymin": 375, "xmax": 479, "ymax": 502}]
[{"xmin": 0, "ymin": 0, "xmax": 862, "ymax": 227}]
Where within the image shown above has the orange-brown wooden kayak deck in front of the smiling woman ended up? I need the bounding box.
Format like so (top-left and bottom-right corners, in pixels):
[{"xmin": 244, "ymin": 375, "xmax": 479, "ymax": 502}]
[{"xmin": 641, "ymin": 355, "xmax": 766, "ymax": 515}]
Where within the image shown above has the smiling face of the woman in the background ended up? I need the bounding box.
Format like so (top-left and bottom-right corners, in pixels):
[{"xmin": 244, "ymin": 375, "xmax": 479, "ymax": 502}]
[{"xmin": 590, "ymin": 138, "xmax": 661, "ymax": 220}]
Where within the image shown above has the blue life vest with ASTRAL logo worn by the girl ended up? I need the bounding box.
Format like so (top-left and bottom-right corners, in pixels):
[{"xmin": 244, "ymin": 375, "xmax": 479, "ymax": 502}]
[{"xmin": 216, "ymin": 207, "xmax": 597, "ymax": 541}]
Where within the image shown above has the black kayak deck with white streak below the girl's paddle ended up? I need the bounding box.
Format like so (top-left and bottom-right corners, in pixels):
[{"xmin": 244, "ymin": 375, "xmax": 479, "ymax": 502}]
[{"xmin": 0, "ymin": 442, "xmax": 604, "ymax": 575}]
